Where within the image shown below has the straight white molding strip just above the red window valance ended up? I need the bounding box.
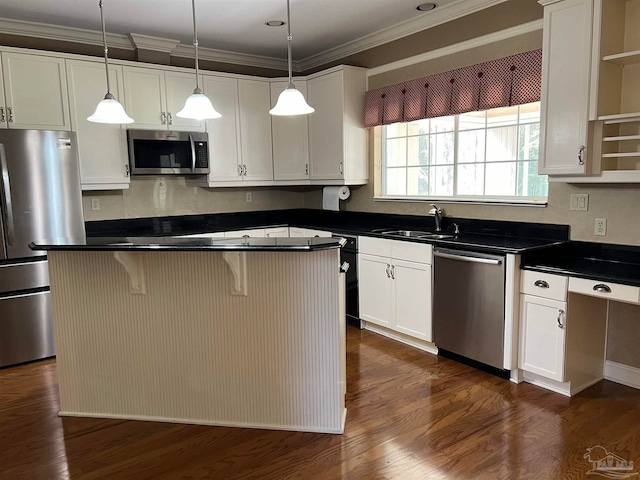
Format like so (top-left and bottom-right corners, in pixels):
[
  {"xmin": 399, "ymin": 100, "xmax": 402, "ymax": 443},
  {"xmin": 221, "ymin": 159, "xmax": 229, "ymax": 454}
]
[{"xmin": 367, "ymin": 19, "xmax": 543, "ymax": 77}]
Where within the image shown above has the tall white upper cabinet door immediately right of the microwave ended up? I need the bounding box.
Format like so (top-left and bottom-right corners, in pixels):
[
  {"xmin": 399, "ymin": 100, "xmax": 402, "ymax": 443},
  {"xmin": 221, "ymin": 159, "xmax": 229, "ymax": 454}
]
[{"xmin": 202, "ymin": 75, "xmax": 242, "ymax": 182}]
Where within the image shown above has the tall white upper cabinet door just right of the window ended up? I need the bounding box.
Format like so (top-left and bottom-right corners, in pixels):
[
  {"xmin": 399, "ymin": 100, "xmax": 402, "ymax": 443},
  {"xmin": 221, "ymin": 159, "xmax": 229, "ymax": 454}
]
[{"xmin": 538, "ymin": 0, "xmax": 597, "ymax": 175}]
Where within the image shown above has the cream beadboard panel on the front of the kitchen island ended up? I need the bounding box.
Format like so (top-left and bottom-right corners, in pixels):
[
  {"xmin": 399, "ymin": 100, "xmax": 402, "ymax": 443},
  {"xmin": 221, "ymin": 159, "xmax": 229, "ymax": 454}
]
[{"xmin": 49, "ymin": 250, "xmax": 345, "ymax": 433}]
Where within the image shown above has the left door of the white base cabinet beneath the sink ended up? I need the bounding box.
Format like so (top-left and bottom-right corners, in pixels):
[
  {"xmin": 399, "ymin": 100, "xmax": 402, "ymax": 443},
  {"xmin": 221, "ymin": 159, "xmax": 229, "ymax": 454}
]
[{"xmin": 358, "ymin": 254, "xmax": 394, "ymax": 327}]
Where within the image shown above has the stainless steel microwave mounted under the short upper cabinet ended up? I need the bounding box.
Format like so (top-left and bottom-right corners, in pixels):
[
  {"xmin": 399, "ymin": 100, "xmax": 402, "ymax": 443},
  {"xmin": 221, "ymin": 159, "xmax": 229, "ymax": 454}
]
[{"xmin": 127, "ymin": 130, "xmax": 209, "ymax": 175}]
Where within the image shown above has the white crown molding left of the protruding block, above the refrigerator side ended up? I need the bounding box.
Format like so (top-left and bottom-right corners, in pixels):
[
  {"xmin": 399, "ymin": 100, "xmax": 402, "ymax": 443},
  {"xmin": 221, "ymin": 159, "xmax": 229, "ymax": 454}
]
[{"xmin": 0, "ymin": 18, "xmax": 133, "ymax": 50}]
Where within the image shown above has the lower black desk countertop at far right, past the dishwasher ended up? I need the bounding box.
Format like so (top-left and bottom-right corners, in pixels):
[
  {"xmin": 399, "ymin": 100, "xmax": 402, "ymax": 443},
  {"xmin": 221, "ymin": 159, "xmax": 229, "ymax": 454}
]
[{"xmin": 521, "ymin": 242, "xmax": 640, "ymax": 287}]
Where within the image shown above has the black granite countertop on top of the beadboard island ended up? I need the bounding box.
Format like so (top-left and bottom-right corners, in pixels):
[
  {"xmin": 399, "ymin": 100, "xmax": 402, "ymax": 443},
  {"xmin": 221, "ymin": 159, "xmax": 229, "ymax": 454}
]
[{"xmin": 29, "ymin": 237, "xmax": 344, "ymax": 252}]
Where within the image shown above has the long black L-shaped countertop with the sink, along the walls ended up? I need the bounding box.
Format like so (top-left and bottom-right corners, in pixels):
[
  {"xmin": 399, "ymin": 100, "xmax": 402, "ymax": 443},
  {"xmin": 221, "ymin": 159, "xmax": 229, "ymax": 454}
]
[{"xmin": 86, "ymin": 209, "xmax": 569, "ymax": 253}]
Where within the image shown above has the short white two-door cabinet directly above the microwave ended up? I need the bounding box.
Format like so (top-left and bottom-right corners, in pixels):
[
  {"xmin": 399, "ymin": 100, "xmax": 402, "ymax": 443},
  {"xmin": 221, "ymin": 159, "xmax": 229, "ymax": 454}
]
[{"xmin": 123, "ymin": 67, "xmax": 204, "ymax": 132}]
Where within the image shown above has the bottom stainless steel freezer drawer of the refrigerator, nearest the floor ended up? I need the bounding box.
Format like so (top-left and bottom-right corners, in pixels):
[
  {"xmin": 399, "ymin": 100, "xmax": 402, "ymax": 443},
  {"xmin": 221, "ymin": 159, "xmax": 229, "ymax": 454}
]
[{"xmin": 0, "ymin": 292, "xmax": 55, "ymax": 367}]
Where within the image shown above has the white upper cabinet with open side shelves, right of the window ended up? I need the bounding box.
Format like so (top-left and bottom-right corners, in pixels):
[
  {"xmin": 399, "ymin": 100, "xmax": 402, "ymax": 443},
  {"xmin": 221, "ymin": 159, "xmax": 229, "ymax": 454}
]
[{"xmin": 539, "ymin": 0, "xmax": 640, "ymax": 183}]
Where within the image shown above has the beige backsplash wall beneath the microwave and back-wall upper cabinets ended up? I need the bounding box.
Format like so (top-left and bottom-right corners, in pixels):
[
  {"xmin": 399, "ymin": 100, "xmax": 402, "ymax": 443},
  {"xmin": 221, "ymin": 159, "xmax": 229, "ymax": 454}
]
[{"xmin": 82, "ymin": 176, "xmax": 304, "ymax": 221}]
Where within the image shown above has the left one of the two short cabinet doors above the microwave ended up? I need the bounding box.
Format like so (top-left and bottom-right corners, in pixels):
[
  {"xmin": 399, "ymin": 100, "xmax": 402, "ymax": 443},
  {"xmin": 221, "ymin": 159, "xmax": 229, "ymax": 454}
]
[{"xmin": 121, "ymin": 67, "xmax": 167, "ymax": 130}]
